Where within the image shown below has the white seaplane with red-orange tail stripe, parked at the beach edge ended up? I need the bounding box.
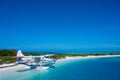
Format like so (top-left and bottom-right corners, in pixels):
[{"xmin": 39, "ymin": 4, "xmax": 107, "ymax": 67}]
[{"xmin": 13, "ymin": 50, "xmax": 56, "ymax": 69}]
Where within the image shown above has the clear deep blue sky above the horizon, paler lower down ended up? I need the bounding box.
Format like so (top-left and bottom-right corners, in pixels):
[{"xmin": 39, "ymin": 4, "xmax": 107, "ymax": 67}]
[{"xmin": 0, "ymin": 0, "xmax": 120, "ymax": 50}]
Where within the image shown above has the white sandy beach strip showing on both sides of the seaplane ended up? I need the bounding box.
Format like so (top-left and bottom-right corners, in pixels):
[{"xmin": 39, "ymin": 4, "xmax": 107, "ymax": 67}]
[{"xmin": 0, "ymin": 55, "xmax": 120, "ymax": 72}]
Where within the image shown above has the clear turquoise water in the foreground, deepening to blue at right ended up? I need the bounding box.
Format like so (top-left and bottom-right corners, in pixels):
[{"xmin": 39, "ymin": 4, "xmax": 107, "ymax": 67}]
[{"xmin": 0, "ymin": 57, "xmax": 120, "ymax": 80}]
